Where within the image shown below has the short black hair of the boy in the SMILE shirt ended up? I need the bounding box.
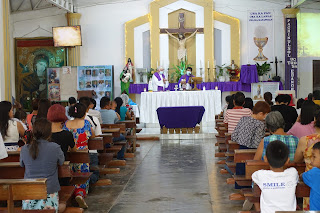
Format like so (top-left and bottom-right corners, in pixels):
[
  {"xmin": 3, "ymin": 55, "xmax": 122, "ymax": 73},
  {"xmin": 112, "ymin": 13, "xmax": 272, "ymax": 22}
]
[{"xmin": 266, "ymin": 140, "xmax": 289, "ymax": 168}]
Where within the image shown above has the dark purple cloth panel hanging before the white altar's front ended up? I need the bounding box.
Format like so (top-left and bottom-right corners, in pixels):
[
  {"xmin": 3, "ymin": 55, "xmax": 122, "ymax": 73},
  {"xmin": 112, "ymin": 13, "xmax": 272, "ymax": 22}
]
[{"xmin": 157, "ymin": 106, "xmax": 205, "ymax": 128}]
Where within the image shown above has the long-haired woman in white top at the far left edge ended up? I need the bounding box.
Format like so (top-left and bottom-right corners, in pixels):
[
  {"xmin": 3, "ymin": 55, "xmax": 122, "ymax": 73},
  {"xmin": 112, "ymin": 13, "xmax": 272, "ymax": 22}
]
[{"xmin": 0, "ymin": 101, "xmax": 25, "ymax": 151}]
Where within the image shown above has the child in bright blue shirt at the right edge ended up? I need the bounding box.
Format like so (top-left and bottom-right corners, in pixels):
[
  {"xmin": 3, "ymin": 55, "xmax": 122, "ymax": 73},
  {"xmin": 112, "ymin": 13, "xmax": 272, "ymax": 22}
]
[{"xmin": 302, "ymin": 142, "xmax": 320, "ymax": 211}]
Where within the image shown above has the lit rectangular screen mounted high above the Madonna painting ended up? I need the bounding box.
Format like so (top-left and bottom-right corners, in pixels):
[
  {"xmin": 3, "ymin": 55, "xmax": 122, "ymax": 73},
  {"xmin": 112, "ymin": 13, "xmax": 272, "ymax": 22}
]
[{"xmin": 52, "ymin": 26, "xmax": 82, "ymax": 47}]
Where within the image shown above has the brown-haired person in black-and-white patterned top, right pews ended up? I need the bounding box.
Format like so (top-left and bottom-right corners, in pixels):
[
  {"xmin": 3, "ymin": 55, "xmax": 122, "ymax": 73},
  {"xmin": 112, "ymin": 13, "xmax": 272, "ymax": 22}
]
[{"xmin": 231, "ymin": 101, "xmax": 270, "ymax": 149}]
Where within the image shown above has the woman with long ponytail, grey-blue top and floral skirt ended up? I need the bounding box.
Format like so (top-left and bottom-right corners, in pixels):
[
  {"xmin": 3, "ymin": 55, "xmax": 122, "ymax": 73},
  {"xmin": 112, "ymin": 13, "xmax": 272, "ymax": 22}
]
[{"xmin": 20, "ymin": 118, "xmax": 65, "ymax": 212}]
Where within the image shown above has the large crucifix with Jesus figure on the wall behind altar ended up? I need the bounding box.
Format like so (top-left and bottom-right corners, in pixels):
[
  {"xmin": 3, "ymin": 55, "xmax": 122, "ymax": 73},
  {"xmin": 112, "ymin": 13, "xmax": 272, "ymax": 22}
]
[{"xmin": 160, "ymin": 13, "xmax": 204, "ymax": 62}]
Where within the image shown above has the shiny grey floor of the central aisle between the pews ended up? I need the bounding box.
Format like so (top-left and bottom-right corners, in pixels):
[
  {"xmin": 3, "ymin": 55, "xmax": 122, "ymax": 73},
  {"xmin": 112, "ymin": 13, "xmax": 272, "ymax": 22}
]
[{"xmin": 86, "ymin": 139, "xmax": 241, "ymax": 213}]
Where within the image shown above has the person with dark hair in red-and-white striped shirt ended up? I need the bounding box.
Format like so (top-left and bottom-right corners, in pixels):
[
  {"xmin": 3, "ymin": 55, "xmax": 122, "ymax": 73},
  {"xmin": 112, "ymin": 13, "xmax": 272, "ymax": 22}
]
[{"xmin": 223, "ymin": 92, "xmax": 252, "ymax": 133}]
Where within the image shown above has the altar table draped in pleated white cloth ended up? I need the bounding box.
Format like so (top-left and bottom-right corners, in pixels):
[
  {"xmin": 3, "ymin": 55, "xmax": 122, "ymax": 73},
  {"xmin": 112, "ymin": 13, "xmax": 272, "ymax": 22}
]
[{"xmin": 140, "ymin": 90, "xmax": 221, "ymax": 124}]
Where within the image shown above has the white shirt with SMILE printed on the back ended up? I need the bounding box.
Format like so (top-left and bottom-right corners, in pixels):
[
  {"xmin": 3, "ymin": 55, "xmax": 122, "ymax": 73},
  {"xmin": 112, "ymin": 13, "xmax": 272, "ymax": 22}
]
[{"xmin": 252, "ymin": 167, "xmax": 299, "ymax": 213}]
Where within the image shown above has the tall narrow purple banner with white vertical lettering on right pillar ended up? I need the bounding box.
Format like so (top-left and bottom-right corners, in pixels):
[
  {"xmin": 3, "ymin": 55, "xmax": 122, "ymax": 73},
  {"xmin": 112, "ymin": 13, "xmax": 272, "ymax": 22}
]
[{"xmin": 285, "ymin": 18, "xmax": 298, "ymax": 93}]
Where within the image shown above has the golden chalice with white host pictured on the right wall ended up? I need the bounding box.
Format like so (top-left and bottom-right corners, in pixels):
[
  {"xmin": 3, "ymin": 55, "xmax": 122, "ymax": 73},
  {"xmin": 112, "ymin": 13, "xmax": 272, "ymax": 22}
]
[{"xmin": 253, "ymin": 26, "xmax": 269, "ymax": 61}]
